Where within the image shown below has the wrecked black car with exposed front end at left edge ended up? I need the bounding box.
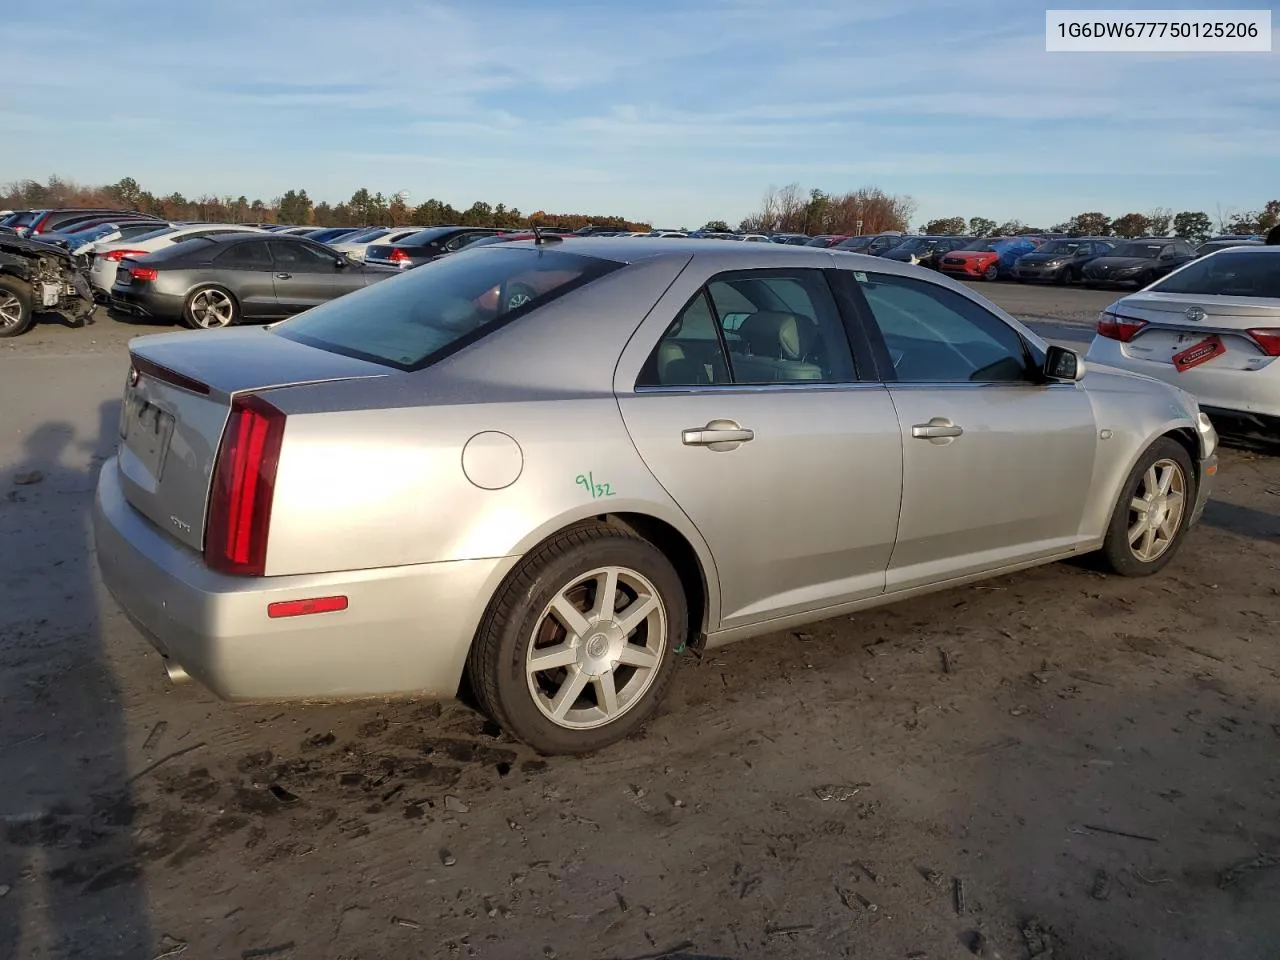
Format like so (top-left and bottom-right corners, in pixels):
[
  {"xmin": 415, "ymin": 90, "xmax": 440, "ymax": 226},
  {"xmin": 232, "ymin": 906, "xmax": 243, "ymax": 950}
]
[{"xmin": 0, "ymin": 236, "xmax": 93, "ymax": 337}]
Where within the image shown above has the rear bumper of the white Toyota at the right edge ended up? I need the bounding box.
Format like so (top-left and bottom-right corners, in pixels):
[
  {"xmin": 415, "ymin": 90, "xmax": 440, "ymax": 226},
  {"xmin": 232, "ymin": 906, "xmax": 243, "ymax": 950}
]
[{"xmin": 1084, "ymin": 337, "xmax": 1280, "ymax": 417}]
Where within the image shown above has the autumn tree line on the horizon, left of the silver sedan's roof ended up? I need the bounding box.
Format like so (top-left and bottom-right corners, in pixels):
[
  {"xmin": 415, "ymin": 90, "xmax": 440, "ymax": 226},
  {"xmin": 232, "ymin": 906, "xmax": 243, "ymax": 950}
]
[{"xmin": 0, "ymin": 175, "xmax": 649, "ymax": 230}]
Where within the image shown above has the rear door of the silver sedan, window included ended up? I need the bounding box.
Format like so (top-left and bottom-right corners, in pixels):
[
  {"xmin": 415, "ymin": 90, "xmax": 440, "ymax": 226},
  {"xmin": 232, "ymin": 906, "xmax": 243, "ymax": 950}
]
[{"xmin": 616, "ymin": 269, "xmax": 901, "ymax": 628}]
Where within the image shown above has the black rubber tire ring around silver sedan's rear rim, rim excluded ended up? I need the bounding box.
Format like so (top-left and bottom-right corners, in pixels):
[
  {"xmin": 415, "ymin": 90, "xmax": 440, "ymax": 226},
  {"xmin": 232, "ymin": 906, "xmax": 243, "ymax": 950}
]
[{"xmin": 483, "ymin": 538, "xmax": 689, "ymax": 754}]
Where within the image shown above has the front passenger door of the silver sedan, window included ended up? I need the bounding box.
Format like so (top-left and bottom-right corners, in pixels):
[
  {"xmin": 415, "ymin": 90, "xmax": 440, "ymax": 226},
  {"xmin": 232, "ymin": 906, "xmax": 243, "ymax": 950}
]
[{"xmin": 845, "ymin": 271, "xmax": 1097, "ymax": 591}]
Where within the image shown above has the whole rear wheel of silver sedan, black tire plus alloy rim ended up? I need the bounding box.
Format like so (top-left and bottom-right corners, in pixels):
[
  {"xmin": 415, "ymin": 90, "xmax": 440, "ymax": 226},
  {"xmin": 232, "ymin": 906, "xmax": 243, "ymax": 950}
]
[{"xmin": 467, "ymin": 522, "xmax": 689, "ymax": 754}]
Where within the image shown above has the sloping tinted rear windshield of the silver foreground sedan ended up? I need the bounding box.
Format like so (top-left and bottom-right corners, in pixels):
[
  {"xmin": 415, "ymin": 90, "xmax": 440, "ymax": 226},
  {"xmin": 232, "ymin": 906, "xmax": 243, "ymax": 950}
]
[{"xmin": 273, "ymin": 244, "xmax": 621, "ymax": 370}]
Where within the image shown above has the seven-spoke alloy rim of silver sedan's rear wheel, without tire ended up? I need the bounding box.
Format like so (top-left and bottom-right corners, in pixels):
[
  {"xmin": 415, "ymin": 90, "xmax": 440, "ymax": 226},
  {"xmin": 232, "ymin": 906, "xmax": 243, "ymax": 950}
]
[{"xmin": 525, "ymin": 567, "xmax": 667, "ymax": 730}]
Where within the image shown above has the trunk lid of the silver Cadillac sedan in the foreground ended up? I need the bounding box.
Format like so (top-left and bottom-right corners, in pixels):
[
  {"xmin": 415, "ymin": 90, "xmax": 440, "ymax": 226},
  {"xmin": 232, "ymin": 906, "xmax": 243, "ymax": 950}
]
[{"xmin": 118, "ymin": 328, "xmax": 390, "ymax": 550}]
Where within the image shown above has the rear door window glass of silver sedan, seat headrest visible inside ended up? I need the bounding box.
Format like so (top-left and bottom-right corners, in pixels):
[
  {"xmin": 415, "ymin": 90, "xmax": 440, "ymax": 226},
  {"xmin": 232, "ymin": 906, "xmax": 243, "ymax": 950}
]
[{"xmin": 636, "ymin": 270, "xmax": 856, "ymax": 387}]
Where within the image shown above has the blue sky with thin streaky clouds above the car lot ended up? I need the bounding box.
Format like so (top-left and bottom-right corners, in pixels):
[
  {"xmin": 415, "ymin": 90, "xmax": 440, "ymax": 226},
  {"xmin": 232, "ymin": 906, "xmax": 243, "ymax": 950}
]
[{"xmin": 0, "ymin": 0, "xmax": 1280, "ymax": 227}]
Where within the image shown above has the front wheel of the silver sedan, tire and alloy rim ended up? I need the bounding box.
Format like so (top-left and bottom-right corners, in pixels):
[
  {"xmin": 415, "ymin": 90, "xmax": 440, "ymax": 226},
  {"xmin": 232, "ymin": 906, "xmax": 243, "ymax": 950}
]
[{"xmin": 1101, "ymin": 436, "xmax": 1196, "ymax": 577}]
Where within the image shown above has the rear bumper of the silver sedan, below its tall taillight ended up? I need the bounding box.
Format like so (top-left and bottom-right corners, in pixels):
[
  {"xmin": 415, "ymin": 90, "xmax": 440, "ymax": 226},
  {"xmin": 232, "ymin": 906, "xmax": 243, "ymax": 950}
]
[{"xmin": 93, "ymin": 457, "xmax": 517, "ymax": 700}]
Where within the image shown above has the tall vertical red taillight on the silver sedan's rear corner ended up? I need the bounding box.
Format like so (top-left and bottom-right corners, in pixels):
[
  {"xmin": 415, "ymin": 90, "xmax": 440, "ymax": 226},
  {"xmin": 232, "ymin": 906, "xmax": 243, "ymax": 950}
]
[{"xmin": 205, "ymin": 394, "xmax": 284, "ymax": 576}]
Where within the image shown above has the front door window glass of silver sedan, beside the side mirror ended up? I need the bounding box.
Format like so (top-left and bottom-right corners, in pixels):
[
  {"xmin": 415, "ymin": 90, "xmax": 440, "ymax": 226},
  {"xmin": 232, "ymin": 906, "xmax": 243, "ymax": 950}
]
[{"xmin": 855, "ymin": 274, "xmax": 1029, "ymax": 383}]
